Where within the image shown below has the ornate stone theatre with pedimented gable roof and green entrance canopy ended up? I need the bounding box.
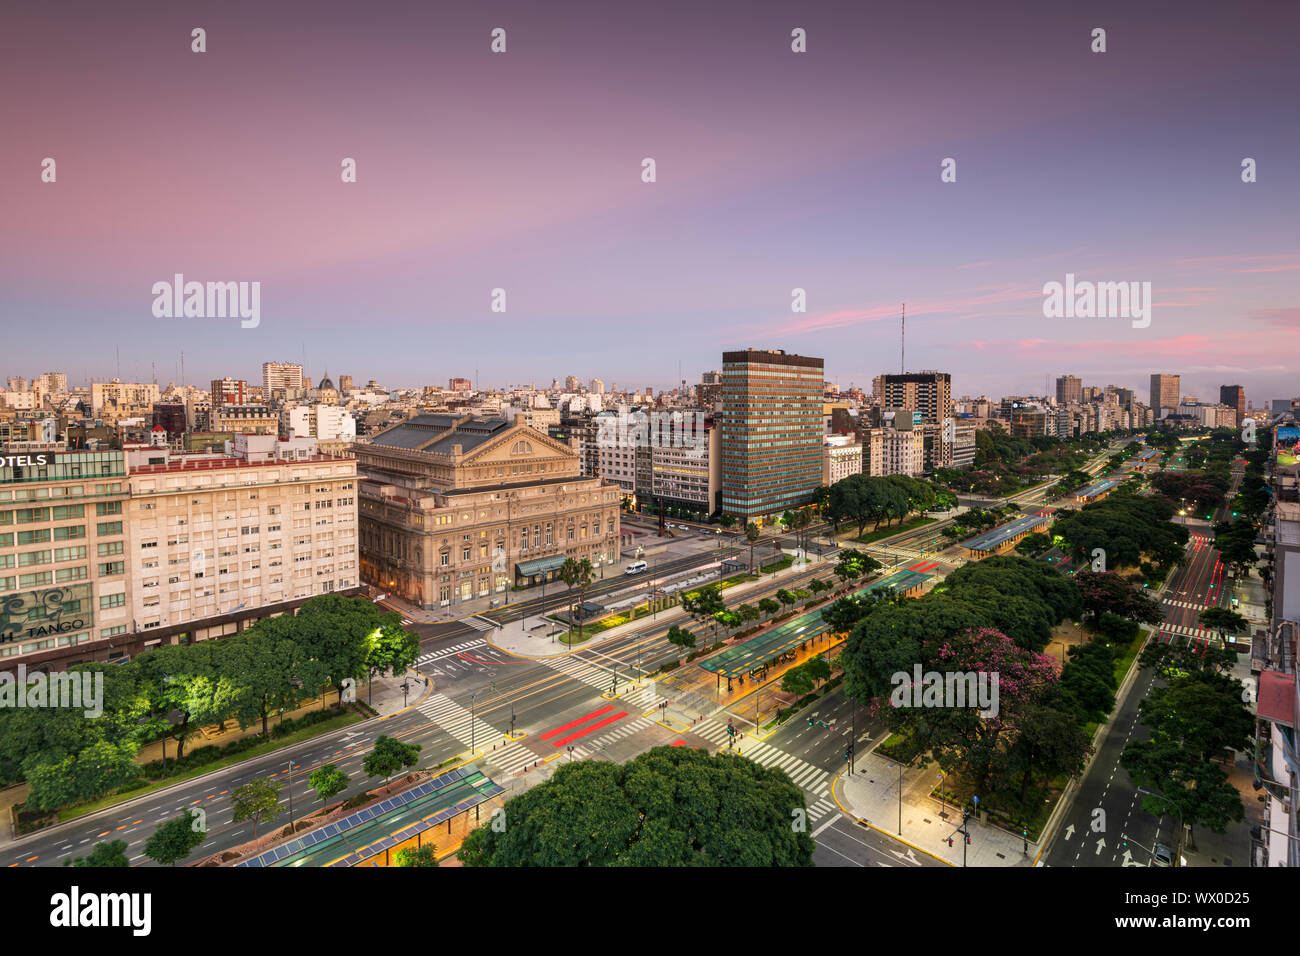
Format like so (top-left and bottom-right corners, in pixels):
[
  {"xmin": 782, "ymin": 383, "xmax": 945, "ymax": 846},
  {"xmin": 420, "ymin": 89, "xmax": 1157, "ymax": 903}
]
[{"xmin": 352, "ymin": 415, "xmax": 620, "ymax": 607}]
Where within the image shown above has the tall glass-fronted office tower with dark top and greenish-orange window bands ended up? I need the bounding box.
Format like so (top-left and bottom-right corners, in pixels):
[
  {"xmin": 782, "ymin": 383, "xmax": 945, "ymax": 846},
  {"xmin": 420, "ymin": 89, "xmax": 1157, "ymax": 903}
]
[{"xmin": 722, "ymin": 349, "xmax": 826, "ymax": 523}]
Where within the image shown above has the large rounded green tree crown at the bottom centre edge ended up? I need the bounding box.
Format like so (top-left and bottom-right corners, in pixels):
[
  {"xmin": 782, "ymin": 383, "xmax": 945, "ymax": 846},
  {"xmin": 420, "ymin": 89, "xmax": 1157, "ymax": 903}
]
[{"xmin": 459, "ymin": 747, "xmax": 814, "ymax": 866}]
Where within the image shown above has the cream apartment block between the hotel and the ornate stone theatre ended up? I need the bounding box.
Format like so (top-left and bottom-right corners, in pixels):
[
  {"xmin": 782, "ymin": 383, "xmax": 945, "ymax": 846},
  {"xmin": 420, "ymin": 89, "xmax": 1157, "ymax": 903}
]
[{"xmin": 125, "ymin": 445, "xmax": 360, "ymax": 646}]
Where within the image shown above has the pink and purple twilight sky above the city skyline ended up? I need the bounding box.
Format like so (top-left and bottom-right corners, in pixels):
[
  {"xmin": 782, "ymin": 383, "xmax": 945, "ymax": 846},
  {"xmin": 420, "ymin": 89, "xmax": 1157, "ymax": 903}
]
[{"xmin": 0, "ymin": 0, "xmax": 1300, "ymax": 403}]
